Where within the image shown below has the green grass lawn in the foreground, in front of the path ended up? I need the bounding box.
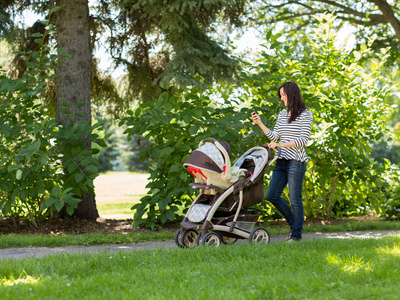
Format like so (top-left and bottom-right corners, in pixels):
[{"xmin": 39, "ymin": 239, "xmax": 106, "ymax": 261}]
[{"xmin": 0, "ymin": 236, "xmax": 400, "ymax": 299}]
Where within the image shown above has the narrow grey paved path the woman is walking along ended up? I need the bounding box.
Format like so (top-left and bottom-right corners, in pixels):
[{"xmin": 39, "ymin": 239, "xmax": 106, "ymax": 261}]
[{"xmin": 0, "ymin": 230, "xmax": 400, "ymax": 260}]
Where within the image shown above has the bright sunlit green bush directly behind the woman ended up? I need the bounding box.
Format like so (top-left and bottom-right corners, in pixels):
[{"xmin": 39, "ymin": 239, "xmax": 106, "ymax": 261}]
[{"xmin": 245, "ymin": 15, "xmax": 390, "ymax": 218}]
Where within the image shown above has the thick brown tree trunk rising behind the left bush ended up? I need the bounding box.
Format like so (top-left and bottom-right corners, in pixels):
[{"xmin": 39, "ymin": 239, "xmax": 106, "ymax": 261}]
[{"xmin": 55, "ymin": 0, "xmax": 99, "ymax": 220}]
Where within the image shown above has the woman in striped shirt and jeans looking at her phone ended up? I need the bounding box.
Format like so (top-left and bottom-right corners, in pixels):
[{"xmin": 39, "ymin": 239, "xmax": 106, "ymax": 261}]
[{"xmin": 252, "ymin": 82, "xmax": 313, "ymax": 242}]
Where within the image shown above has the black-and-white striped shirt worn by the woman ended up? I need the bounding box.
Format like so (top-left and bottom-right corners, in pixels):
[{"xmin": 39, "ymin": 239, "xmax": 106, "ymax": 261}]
[{"xmin": 266, "ymin": 109, "xmax": 313, "ymax": 162}]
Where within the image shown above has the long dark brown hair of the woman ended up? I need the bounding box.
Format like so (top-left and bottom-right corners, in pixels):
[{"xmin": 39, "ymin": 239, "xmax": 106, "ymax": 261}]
[{"xmin": 278, "ymin": 81, "xmax": 306, "ymax": 123}]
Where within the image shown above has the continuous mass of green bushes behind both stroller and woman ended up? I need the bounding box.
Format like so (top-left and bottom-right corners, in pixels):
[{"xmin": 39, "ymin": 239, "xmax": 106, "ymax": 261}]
[{"xmin": 122, "ymin": 15, "xmax": 400, "ymax": 227}]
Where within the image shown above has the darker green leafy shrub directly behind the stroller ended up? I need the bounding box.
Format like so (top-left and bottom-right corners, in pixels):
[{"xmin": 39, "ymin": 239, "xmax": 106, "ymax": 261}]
[{"xmin": 120, "ymin": 90, "xmax": 260, "ymax": 228}]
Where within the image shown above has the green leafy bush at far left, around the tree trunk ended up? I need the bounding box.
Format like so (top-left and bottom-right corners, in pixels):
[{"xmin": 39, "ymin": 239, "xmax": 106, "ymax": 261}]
[{"xmin": 0, "ymin": 17, "xmax": 105, "ymax": 225}]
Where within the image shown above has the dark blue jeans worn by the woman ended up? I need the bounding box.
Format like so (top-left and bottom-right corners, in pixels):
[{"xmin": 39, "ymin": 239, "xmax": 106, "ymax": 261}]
[{"xmin": 267, "ymin": 159, "xmax": 307, "ymax": 238}]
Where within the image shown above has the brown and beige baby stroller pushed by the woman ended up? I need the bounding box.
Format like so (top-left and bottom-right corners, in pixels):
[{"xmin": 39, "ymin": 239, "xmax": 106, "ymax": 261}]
[{"xmin": 175, "ymin": 138, "xmax": 280, "ymax": 247}]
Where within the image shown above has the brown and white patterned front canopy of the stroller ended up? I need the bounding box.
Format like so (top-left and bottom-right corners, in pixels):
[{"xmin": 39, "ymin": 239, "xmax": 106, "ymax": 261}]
[{"xmin": 183, "ymin": 142, "xmax": 231, "ymax": 173}]
